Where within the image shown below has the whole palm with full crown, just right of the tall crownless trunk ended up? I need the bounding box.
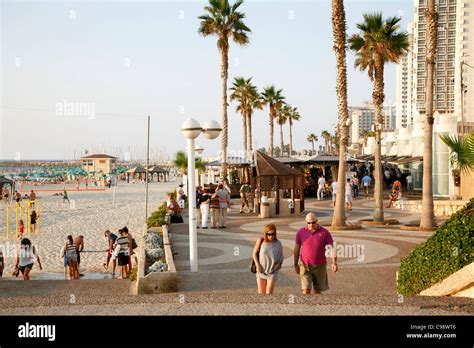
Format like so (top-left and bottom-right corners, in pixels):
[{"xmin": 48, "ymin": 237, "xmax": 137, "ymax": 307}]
[{"xmin": 349, "ymin": 13, "xmax": 409, "ymax": 222}]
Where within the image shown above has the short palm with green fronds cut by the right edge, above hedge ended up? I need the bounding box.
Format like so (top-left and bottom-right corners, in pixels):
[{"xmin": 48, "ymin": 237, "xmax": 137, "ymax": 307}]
[{"xmin": 439, "ymin": 132, "xmax": 474, "ymax": 196}]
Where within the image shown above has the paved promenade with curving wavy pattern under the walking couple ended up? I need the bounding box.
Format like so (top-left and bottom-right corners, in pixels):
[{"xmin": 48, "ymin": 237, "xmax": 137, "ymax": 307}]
[{"xmin": 0, "ymin": 199, "xmax": 474, "ymax": 315}]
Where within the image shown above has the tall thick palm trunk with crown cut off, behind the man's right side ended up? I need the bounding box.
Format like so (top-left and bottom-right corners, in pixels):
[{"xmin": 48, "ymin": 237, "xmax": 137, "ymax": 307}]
[{"xmin": 331, "ymin": 0, "xmax": 348, "ymax": 227}]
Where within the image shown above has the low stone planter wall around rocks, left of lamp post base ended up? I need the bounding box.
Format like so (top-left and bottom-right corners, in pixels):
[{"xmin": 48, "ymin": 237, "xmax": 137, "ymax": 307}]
[{"xmin": 136, "ymin": 225, "xmax": 178, "ymax": 294}]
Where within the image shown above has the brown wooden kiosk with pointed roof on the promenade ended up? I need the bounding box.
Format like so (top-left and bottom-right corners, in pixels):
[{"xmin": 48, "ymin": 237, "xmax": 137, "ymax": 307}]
[{"xmin": 252, "ymin": 151, "xmax": 304, "ymax": 217}]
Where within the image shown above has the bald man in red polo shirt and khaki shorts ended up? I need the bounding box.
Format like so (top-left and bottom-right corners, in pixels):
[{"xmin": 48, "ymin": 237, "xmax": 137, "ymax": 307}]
[{"xmin": 293, "ymin": 213, "xmax": 337, "ymax": 294}]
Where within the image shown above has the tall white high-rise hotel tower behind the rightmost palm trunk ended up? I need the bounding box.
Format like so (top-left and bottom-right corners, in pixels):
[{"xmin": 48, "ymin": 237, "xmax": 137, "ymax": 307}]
[{"xmin": 396, "ymin": 0, "xmax": 474, "ymax": 196}]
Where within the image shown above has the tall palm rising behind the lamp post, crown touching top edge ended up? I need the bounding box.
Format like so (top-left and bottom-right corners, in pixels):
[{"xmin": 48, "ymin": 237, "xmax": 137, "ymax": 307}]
[{"xmin": 198, "ymin": 0, "xmax": 251, "ymax": 179}]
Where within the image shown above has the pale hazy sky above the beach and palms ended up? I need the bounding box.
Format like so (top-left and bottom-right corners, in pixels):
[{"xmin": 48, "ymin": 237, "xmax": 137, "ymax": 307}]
[{"xmin": 0, "ymin": 0, "xmax": 413, "ymax": 160}]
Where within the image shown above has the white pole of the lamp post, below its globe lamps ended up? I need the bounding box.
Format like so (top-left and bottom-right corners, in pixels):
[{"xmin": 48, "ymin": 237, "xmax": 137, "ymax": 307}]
[{"xmin": 188, "ymin": 139, "xmax": 198, "ymax": 272}]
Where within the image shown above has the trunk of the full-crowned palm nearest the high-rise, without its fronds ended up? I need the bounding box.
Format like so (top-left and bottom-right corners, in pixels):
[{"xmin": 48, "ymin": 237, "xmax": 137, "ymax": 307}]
[{"xmin": 372, "ymin": 53, "xmax": 385, "ymax": 222}]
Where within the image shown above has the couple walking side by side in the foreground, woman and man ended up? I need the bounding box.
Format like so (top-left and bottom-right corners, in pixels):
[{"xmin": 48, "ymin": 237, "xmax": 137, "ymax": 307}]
[{"xmin": 252, "ymin": 213, "xmax": 338, "ymax": 294}]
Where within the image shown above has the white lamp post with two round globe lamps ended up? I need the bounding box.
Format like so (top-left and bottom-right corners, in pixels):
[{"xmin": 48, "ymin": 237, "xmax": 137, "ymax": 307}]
[{"xmin": 181, "ymin": 118, "xmax": 222, "ymax": 272}]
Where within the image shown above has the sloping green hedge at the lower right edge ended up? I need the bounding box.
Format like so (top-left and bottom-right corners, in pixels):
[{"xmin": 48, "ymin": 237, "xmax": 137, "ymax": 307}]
[{"xmin": 397, "ymin": 198, "xmax": 474, "ymax": 296}]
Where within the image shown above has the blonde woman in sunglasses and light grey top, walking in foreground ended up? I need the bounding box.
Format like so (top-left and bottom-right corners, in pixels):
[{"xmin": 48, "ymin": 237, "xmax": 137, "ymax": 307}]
[{"xmin": 252, "ymin": 224, "xmax": 284, "ymax": 295}]
